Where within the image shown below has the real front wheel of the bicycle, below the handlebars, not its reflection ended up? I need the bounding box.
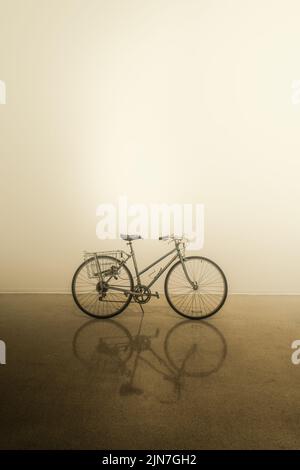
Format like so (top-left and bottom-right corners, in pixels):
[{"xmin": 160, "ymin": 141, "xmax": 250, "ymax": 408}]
[{"xmin": 165, "ymin": 256, "xmax": 228, "ymax": 319}]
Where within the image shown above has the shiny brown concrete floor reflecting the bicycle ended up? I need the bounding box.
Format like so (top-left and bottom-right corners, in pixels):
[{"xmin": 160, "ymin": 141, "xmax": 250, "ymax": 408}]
[{"xmin": 0, "ymin": 295, "xmax": 300, "ymax": 449}]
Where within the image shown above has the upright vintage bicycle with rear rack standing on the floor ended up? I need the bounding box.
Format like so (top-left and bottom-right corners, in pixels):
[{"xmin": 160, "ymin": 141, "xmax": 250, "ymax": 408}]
[{"xmin": 72, "ymin": 234, "xmax": 228, "ymax": 319}]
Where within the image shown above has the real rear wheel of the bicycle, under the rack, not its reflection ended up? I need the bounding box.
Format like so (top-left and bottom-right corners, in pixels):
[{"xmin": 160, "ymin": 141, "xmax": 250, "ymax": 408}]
[{"xmin": 72, "ymin": 255, "xmax": 133, "ymax": 318}]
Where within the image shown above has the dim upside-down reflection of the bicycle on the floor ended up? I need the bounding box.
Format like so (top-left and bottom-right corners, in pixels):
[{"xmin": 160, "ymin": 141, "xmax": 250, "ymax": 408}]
[{"xmin": 73, "ymin": 315, "xmax": 227, "ymax": 403}]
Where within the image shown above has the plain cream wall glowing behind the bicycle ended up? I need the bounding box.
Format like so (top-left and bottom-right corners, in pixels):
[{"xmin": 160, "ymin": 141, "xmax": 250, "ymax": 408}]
[{"xmin": 0, "ymin": 0, "xmax": 300, "ymax": 293}]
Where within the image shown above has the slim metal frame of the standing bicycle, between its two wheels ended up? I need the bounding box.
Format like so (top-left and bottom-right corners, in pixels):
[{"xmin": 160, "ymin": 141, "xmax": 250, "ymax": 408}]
[{"xmin": 105, "ymin": 240, "xmax": 195, "ymax": 295}]
